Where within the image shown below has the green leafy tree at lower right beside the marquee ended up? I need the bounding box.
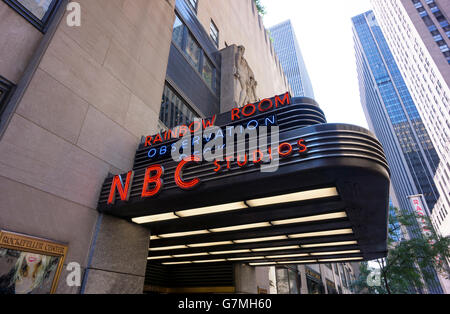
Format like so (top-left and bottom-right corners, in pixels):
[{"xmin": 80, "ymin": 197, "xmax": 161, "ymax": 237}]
[{"xmin": 353, "ymin": 208, "xmax": 450, "ymax": 294}]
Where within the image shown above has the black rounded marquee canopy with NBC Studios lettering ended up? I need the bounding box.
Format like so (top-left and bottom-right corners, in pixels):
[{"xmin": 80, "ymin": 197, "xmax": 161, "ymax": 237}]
[{"xmin": 98, "ymin": 94, "xmax": 390, "ymax": 267}]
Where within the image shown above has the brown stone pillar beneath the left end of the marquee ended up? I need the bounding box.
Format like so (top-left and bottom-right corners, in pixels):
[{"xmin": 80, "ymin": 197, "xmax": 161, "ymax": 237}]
[{"xmin": 81, "ymin": 215, "xmax": 150, "ymax": 294}]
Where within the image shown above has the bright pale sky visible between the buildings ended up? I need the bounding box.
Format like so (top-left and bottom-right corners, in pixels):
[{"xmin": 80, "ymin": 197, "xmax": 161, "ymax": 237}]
[{"xmin": 262, "ymin": 0, "xmax": 371, "ymax": 128}]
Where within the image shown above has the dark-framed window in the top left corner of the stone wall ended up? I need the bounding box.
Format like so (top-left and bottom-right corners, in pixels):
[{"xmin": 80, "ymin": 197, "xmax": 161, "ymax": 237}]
[{"xmin": 3, "ymin": 0, "xmax": 61, "ymax": 33}]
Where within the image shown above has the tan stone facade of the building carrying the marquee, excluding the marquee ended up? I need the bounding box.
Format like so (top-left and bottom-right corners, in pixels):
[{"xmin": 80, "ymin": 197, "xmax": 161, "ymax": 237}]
[{"xmin": 0, "ymin": 0, "xmax": 290, "ymax": 293}]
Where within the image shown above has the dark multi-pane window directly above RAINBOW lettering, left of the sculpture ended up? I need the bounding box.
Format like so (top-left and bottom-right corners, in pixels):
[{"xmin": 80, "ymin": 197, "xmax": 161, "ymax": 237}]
[{"xmin": 159, "ymin": 84, "xmax": 199, "ymax": 129}]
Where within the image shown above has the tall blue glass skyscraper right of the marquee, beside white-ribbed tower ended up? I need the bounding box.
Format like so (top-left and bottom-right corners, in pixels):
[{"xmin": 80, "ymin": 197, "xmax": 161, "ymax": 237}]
[{"xmin": 352, "ymin": 11, "xmax": 443, "ymax": 293}]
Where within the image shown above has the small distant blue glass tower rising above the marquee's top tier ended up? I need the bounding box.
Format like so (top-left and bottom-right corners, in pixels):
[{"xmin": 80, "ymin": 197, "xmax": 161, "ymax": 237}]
[{"xmin": 269, "ymin": 20, "xmax": 314, "ymax": 98}]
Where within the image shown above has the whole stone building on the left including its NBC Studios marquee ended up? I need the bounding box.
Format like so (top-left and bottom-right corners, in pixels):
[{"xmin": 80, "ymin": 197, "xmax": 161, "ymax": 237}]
[{"xmin": 0, "ymin": 0, "xmax": 382, "ymax": 294}]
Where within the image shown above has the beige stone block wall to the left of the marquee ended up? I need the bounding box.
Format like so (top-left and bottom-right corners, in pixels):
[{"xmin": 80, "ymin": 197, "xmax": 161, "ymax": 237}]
[{"xmin": 0, "ymin": 0, "xmax": 174, "ymax": 293}]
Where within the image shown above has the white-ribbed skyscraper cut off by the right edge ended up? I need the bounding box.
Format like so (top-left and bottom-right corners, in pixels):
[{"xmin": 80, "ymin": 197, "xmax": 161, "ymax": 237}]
[{"xmin": 372, "ymin": 0, "xmax": 450, "ymax": 236}]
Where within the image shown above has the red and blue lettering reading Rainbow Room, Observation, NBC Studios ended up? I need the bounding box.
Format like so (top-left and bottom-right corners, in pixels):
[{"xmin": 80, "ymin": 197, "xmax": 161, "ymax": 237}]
[{"xmin": 107, "ymin": 93, "xmax": 308, "ymax": 205}]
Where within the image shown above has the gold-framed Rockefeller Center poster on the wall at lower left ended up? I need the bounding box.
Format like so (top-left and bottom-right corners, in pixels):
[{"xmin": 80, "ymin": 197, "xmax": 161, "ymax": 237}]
[{"xmin": 0, "ymin": 230, "xmax": 68, "ymax": 294}]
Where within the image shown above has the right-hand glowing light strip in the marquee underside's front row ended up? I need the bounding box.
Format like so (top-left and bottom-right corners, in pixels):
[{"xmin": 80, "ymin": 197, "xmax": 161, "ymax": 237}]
[{"xmin": 247, "ymin": 188, "xmax": 339, "ymax": 207}]
